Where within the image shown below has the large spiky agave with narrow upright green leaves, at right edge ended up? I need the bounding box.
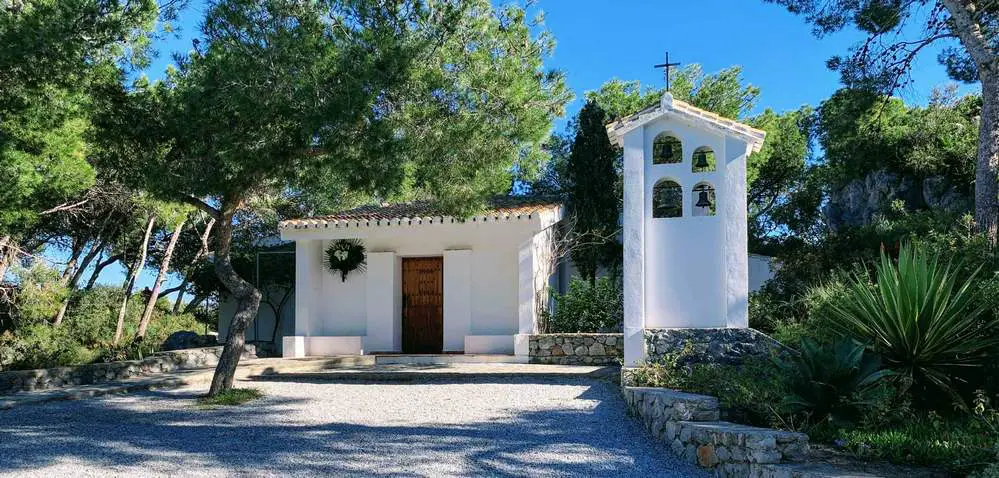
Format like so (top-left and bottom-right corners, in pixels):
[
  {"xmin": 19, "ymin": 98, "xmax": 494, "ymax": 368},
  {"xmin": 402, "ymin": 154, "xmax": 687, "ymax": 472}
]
[{"xmin": 825, "ymin": 244, "xmax": 999, "ymax": 397}]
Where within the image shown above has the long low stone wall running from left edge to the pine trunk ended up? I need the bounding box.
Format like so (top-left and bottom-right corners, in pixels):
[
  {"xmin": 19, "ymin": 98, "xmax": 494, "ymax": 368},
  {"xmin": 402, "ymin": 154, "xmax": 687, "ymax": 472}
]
[{"xmin": 0, "ymin": 345, "xmax": 256, "ymax": 395}]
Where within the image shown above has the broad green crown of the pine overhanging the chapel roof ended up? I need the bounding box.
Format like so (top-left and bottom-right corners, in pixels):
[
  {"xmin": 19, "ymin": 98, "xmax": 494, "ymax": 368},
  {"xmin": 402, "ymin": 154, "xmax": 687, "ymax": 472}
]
[{"xmin": 108, "ymin": 0, "xmax": 569, "ymax": 218}]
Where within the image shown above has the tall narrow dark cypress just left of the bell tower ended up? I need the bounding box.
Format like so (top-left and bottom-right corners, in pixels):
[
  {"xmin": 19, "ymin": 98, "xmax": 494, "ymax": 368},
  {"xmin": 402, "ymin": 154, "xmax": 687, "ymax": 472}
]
[{"xmin": 565, "ymin": 101, "xmax": 621, "ymax": 280}]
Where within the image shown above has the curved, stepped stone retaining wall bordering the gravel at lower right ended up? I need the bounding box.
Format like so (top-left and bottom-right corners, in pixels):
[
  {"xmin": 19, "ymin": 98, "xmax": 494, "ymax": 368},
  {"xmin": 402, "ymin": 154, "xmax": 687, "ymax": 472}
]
[{"xmin": 622, "ymin": 387, "xmax": 808, "ymax": 478}]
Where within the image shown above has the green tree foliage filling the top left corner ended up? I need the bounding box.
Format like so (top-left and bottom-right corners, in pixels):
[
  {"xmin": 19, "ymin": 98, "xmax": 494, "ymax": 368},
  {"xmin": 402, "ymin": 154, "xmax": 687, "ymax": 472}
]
[{"xmin": 0, "ymin": 0, "xmax": 159, "ymax": 235}]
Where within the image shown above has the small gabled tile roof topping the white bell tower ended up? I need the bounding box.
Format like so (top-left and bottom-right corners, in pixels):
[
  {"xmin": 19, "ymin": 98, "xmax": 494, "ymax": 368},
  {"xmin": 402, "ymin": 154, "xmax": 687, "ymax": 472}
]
[{"xmin": 607, "ymin": 93, "xmax": 767, "ymax": 152}]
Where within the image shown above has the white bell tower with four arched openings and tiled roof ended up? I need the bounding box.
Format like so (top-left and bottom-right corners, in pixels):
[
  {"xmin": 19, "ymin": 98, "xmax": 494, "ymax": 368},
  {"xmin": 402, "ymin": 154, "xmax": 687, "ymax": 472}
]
[{"xmin": 607, "ymin": 91, "xmax": 765, "ymax": 366}]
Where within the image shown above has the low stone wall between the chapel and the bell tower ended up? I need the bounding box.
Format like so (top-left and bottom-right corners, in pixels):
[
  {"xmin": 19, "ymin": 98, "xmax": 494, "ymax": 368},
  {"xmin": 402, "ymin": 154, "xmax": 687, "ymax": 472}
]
[{"xmin": 529, "ymin": 334, "xmax": 624, "ymax": 365}]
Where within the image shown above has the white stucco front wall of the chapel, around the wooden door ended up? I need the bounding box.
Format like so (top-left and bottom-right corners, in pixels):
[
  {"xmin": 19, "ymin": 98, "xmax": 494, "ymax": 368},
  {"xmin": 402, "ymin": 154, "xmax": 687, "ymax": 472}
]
[{"xmin": 282, "ymin": 213, "xmax": 550, "ymax": 354}]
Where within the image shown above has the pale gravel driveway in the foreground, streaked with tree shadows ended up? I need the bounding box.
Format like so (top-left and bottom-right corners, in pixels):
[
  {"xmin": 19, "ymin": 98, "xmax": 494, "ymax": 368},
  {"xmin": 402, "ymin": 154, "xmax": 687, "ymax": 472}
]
[{"xmin": 0, "ymin": 377, "xmax": 703, "ymax": 477}]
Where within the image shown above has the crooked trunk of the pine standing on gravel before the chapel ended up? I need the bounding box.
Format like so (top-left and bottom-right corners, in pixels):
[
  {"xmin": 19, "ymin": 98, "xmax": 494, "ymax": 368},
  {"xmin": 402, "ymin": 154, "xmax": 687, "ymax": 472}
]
[{"xmin": 208, "ymin": 201, "xmax": 260, "ymax": 397}]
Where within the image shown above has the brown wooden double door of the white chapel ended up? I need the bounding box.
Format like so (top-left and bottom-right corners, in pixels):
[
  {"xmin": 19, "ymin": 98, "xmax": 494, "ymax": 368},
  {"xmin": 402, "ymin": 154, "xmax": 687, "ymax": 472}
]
[{"xmin": 402, "ymin": 257, "xmax": 444, "ymax": 354}]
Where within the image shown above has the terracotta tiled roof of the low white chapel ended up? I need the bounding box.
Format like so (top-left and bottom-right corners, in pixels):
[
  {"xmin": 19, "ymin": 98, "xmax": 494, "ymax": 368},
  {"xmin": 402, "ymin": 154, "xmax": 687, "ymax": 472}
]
[{"xmin": 279, "ymin": 196, "xmax": 561, "ymax": 228}]
